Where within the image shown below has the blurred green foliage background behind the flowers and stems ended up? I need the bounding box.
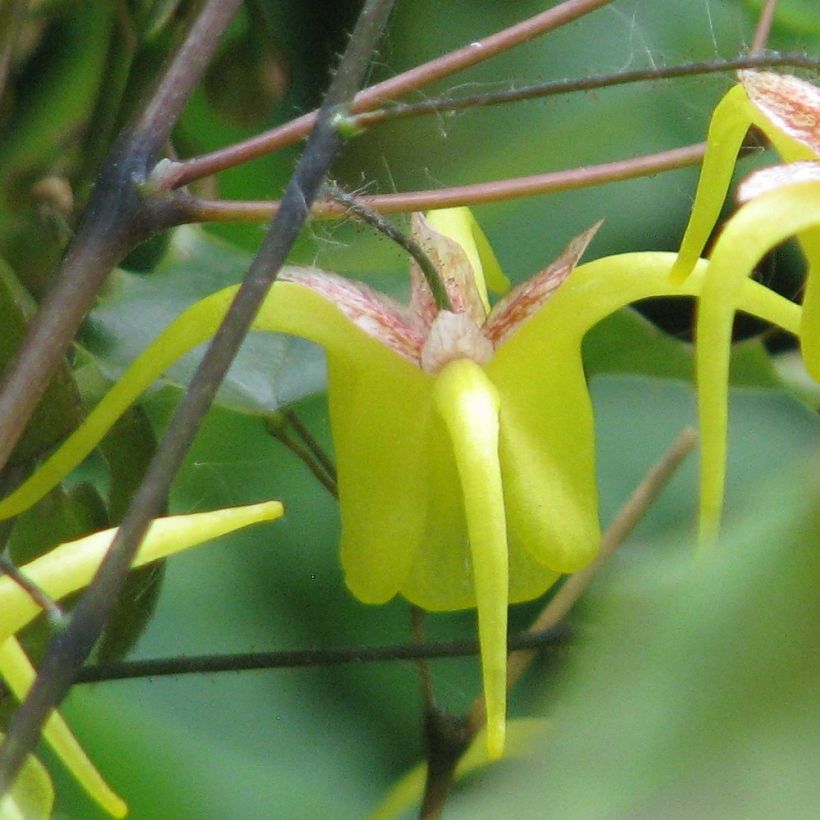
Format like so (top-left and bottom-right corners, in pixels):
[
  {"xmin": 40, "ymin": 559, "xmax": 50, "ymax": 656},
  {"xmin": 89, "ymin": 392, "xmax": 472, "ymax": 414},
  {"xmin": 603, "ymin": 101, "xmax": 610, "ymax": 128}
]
[{"xmin": 0, "ymin": 0, "xmax": 820, "ymax": 820}]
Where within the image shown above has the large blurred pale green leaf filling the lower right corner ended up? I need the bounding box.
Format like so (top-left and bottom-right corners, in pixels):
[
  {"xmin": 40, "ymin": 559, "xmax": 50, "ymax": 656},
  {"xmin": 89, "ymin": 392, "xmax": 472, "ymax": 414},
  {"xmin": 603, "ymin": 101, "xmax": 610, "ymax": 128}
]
[{"xmin": 451, "ymin": 461, "xmax": 820, "ymax": 818}]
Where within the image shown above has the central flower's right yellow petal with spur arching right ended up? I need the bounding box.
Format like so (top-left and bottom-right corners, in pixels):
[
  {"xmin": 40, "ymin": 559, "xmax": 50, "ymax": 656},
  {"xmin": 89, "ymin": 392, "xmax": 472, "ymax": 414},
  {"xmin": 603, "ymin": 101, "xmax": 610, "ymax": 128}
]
[{"xmin": 487, "ymin": 253, "xmax": 800, "ymax": 572}]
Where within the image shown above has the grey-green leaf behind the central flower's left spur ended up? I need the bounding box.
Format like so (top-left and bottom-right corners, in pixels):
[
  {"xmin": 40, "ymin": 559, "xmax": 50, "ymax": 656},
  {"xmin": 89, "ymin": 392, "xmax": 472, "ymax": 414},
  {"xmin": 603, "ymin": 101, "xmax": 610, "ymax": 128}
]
[{"xmin": 82, "ymin": 226, "xmax": 325, "ymax": 414}]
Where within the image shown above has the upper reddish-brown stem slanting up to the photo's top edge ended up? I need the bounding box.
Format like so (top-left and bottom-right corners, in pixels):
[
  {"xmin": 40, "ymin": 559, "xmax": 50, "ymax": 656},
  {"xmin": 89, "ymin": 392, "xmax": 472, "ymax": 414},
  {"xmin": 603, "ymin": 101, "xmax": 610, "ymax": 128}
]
[{"xmin": 160, "ymin": 0, "xmax": 612, "ymax": 188}]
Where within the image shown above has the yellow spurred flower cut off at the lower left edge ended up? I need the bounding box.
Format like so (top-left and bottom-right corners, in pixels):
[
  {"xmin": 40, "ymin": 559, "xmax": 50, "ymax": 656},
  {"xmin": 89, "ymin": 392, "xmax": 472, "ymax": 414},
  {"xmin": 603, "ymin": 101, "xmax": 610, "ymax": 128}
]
[{"xmin": 0, "ymin": 501, "xmax": 282, "ymax": 817}]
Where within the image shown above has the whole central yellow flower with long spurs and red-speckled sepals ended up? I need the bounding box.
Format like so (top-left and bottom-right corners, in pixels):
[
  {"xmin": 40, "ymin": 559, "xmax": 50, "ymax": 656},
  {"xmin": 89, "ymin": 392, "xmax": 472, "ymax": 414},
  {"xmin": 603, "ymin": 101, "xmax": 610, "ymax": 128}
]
[{"xmin": 0, "ymin": 208, "xmax": 799, "ymax": 757}]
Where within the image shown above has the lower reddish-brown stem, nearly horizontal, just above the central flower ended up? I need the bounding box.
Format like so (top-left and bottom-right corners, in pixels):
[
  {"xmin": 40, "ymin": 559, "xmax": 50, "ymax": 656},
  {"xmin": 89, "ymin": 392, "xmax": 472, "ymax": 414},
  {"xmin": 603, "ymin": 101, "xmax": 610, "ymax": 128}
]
[{"xmin": 180, "ymin": 142, "xmax": 706, "ymax": 222}]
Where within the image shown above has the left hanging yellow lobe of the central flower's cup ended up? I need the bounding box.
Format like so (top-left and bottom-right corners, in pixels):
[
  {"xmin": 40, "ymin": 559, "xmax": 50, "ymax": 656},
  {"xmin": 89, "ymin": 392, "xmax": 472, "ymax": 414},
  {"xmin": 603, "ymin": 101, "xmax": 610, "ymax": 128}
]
[{"xmin": 328, "ymin": 348, "xmax": 433, "ymax": 604}]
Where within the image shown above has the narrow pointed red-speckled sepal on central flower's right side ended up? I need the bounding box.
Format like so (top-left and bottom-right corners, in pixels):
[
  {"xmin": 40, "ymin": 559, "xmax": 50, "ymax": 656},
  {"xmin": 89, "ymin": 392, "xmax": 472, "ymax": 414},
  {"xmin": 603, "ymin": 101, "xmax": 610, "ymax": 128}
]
[{"xmin": 482, "ymin": 222, "xmax": 603, "ymax": 347}]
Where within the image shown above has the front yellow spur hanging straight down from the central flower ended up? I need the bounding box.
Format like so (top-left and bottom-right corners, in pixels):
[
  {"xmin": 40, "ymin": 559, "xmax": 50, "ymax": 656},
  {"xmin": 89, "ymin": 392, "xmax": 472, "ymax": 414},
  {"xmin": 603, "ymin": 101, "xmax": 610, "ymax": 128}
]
[{"xmin": 433, "ymin": 359, "xmax": 509, "ymax": 757}]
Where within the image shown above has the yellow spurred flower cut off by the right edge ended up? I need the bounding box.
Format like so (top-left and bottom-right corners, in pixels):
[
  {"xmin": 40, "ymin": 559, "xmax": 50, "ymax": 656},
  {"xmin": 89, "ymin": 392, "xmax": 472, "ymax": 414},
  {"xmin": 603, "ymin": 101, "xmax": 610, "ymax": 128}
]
[{"xmin": 671, "ymin": 71, "xmax": 820, "ymax": 541}]
